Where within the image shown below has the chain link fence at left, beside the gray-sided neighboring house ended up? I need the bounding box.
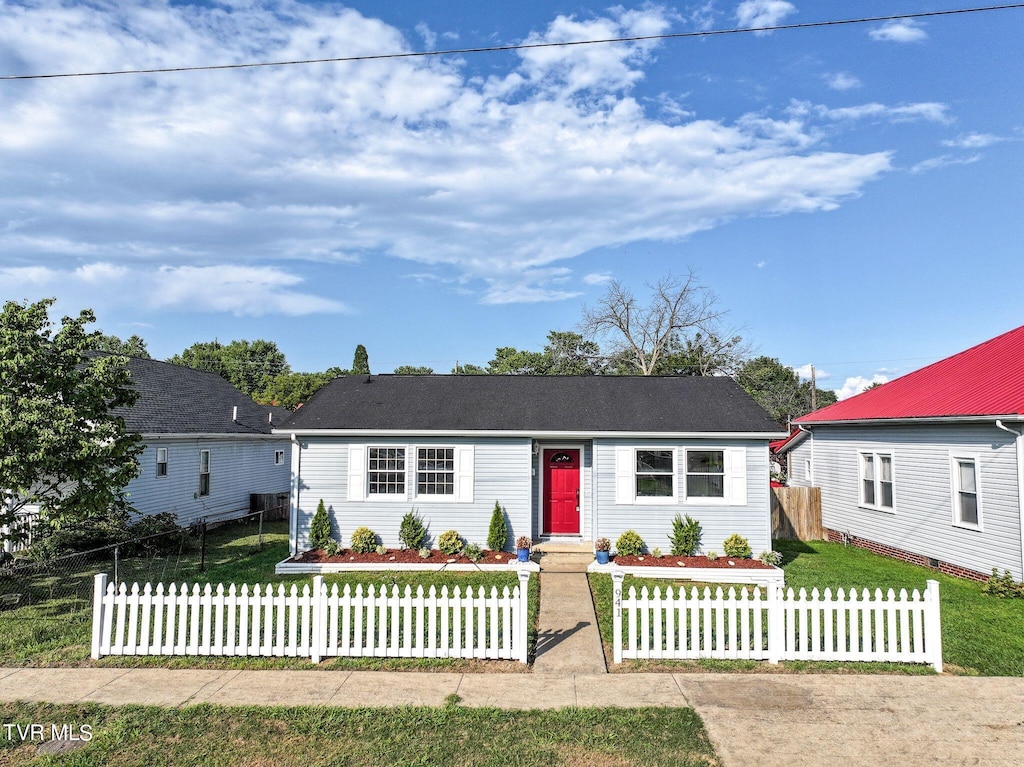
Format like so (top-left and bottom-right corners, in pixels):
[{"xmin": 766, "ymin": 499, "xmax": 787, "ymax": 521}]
[{"xmin": 0, "ymin": 509, "xmax": 272, "ymax": 624}]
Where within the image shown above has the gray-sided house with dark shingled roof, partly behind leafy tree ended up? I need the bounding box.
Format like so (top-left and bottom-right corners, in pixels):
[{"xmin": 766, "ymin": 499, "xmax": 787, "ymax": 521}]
[{"xmin": 116, "ymin": 357, "xmax": 291, "ymax": 525}]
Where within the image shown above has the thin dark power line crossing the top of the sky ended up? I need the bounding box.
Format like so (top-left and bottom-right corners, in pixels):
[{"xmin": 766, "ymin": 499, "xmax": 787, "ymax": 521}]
[{"xmin": 0, "ymin": 3, "xmax": 1024, "ymax": 80}]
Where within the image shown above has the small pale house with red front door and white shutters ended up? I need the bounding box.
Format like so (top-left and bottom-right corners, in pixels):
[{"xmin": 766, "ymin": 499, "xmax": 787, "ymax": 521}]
[{"xmin": 275, "ymin": 375, "xmax": 785, "ymax": 554}]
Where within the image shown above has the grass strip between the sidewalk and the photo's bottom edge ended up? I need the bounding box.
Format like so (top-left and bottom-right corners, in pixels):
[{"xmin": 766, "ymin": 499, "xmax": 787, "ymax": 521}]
[{"xmin": 0, "ymin": 704, "xmax": 721, "ymax": 767}]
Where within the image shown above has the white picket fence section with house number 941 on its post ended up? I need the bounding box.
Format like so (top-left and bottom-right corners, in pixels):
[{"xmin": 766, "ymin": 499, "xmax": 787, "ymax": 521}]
[{"xmin": 612, "ymin": 573, "xmax": 942, "ymax": 672}]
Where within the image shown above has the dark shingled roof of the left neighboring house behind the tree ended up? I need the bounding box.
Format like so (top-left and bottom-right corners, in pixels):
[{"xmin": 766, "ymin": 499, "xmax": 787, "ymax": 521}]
[{"xmin": 104, "ymin": 357, "xmax": 288, "ymax": 434}]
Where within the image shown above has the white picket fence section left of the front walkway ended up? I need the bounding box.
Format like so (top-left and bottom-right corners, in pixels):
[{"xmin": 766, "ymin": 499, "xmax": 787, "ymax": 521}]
[{"xmin": 92, "ymin": 570, "xmax": 529, "ymax": 663}]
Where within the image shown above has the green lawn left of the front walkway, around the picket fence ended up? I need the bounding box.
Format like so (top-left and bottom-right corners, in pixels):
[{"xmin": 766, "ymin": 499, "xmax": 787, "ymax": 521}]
[{"xmin": 0, "ymin": 522, "xmax": 540, "ymax": 672}]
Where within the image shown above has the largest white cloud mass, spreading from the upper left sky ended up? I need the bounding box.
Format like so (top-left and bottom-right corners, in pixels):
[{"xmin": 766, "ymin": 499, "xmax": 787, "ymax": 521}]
[{"xmin": 0, "ymin": 0, "xmax": 913, "ymax": 313}]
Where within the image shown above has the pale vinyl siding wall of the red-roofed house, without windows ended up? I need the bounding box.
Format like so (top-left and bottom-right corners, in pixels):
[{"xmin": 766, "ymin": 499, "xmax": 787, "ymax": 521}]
[{"xmin": 796, "ymin": 423, "xmax": 1024, "ymax": 581}]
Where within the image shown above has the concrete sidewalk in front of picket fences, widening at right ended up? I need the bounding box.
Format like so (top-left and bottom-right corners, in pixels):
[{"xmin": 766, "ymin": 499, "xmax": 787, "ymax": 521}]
[{"xmin": 0, "ymin": 669, "xmax": 1024, "ymax": 767}]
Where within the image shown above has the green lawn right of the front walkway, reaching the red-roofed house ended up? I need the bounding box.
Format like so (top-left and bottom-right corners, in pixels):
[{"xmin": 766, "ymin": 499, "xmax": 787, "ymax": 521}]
[{"xmin": 590, "ymin": 541, "xmax": 1024, "ymax": 676}]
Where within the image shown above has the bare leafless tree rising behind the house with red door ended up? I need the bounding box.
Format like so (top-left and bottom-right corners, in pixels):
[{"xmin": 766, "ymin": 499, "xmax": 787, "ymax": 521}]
[{"xmin": 580, "ymin": 269, "xmax": 725, "ymax": 376}]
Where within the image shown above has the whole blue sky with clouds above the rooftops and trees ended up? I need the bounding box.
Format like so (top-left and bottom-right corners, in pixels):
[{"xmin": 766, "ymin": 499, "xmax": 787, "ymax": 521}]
[{"xmin": 0, "ymin": 0, "xmax": 1024, "ymax": 394}]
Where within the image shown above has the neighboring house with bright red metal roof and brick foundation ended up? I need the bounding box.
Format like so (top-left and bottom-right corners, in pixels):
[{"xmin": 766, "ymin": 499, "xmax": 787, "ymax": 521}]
[{"xmin": 779, "ymin": 326, "xmax": 1024, "ymax": 581}]
